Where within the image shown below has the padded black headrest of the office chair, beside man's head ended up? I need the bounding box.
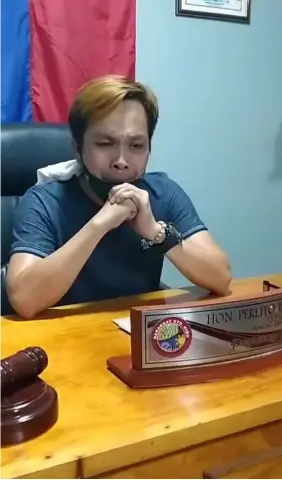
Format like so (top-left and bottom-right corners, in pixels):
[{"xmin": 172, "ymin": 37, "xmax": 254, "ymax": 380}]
[{"xmin": 1, "ymin": 123, "xmax": 75, "ymax": 196}]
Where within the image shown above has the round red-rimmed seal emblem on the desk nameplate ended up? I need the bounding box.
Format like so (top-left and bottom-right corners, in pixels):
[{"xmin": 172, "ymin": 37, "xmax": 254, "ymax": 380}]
[{"xmin": 151, "ymin": 317, "xmax": 192, "ymax": 358}]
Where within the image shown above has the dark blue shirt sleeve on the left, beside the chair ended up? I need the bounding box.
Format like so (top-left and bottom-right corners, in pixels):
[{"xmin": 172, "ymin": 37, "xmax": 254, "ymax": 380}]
[{"xmin": 10, "ymin": 187, "xmax": 56, "ymax": 258}]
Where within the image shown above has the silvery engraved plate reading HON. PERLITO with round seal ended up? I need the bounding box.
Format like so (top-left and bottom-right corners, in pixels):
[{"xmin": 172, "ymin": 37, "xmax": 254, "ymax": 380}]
[{"xmin": 142, "ymin": 294, "xmax": 282, "ymax": 369}]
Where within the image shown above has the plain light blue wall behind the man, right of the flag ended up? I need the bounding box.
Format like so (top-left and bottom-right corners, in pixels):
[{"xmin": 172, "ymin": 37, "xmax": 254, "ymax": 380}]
[{"xmin": 137, "ymin": 0, "xmax": 282, "ymax": 286}]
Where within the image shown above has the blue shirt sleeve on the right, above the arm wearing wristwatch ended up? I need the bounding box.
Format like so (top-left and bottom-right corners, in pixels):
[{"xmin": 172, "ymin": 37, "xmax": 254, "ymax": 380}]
[{"xmin": 166, "ymin": 178, "xmax": 207, "ymax": 238}]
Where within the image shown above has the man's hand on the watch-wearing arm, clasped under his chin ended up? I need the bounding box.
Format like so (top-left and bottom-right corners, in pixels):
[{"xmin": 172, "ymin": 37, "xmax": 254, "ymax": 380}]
[{"xmin": 109, "ymin": 183, "xmax": 160, "ymax": 240}]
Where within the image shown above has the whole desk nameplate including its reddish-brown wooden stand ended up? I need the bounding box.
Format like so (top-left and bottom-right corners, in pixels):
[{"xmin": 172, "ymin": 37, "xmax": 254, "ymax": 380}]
[{"xmin": 107, "ymin": 280, "xmax": 282, "ymax": 388}]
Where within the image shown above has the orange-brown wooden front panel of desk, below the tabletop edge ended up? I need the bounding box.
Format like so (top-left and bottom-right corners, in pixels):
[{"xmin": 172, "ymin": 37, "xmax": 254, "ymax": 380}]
[{"xmin": 95, "ymin": 422, "xmax": 282, "ymax": 479}]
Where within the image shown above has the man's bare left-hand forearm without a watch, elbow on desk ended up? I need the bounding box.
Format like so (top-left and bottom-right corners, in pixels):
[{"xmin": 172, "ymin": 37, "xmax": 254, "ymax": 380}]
[{"xmin": 7, "ymin": 217, "xmax": 107, "ymax": 318}]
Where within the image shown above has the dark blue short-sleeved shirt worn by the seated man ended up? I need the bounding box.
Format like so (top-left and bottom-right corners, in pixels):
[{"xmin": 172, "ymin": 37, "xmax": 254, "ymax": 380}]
[{"xmin": 11, "ymin": 173, "xmax": 206, "ymax": 305}]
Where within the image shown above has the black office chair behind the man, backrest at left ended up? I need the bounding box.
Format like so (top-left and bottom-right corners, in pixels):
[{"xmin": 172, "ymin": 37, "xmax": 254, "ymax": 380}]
[{"xmin": 1, "ymin": 123, "xmax": 75, "ymax": 315}]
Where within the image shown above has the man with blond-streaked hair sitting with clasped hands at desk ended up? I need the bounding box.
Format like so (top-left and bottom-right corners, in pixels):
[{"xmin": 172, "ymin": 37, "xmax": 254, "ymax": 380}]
[{"xmin": 7, "ymin": 76, "xmax": 230, "ymax": 318}]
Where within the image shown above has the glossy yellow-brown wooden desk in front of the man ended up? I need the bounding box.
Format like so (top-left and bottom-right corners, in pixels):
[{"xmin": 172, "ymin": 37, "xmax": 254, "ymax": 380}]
[{"xmin": 2, "ymin": 275, "xmax": 282, "ymax": 478}]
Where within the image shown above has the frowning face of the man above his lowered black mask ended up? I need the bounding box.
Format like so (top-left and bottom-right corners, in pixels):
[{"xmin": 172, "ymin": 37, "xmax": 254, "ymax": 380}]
[{"xmin": 82, "ymin": 100, "xmax": 149, "ymax": 183}]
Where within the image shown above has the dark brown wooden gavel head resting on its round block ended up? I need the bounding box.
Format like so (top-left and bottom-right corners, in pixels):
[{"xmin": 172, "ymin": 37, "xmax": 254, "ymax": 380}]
[{"xmin": 1, "ymin": 347, "xmax": 48, "ymax": 389}]
